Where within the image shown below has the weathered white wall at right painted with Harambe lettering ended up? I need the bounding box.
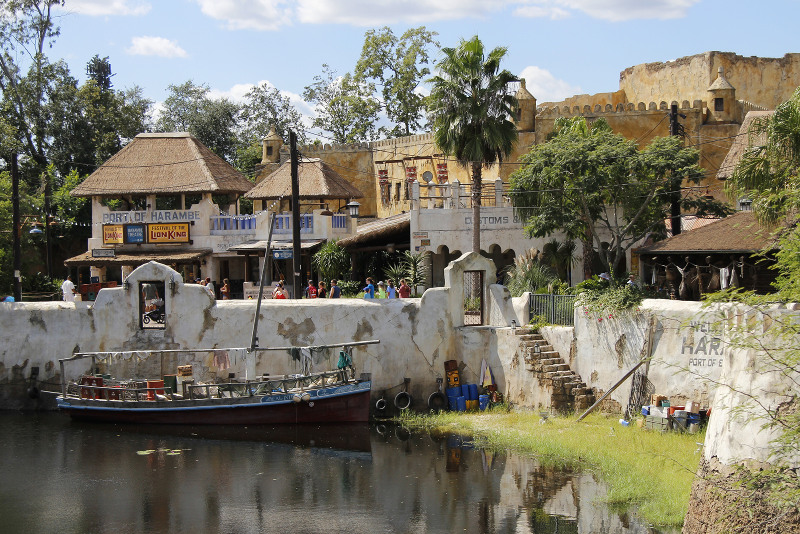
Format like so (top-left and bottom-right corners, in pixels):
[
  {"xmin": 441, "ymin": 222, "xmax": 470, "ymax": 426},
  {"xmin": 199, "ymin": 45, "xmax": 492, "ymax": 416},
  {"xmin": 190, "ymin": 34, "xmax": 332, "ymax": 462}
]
[{"xmin": 571, "ymin": 300, "xmax": 800, "ymax": 472}]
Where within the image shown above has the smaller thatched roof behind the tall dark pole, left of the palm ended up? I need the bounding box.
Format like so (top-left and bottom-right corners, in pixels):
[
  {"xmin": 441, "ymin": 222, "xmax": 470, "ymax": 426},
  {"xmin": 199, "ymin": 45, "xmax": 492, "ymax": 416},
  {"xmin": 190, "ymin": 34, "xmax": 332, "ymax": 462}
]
[{"xmin": 245, "ymin": 158, "xmax": 364, "ymax": 200}]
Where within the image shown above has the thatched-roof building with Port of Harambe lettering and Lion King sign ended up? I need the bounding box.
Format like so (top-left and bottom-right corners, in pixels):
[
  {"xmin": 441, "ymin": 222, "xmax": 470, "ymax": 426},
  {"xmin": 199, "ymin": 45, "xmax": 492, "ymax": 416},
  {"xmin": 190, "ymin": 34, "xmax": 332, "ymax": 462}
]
[{"xmin": 65, "ymin": 133, "xmax": 266, "ymax": 294}]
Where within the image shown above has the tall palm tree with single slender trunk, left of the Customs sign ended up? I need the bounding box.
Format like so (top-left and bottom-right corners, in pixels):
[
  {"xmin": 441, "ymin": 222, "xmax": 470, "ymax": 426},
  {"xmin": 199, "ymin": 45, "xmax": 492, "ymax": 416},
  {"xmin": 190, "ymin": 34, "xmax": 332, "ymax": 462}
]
[{"xmin": 428, "ymin": 35, "xmax": 517, "ymax": 253}]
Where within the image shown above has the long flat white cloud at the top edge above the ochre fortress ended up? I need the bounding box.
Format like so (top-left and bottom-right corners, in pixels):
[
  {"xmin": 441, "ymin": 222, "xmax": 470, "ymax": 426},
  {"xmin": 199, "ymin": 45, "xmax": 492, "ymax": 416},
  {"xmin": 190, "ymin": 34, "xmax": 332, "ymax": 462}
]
[{"xmin": 514, "ymin": 0, "xmax": 700, "ymax": 22}]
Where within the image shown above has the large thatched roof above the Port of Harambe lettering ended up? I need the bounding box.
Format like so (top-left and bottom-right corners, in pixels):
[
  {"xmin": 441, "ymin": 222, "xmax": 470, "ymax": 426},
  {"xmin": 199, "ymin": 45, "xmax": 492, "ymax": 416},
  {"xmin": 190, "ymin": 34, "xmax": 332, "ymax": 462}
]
[{"xmin": 70, "ymin": 133, "xmax": 253, "ymax": 197}]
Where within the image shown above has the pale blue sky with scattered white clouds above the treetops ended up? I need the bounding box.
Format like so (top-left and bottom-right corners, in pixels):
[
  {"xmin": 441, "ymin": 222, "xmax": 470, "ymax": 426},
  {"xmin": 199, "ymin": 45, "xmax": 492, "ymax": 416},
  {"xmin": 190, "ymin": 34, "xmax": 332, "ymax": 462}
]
[{"xmin": 48, "ymin": 0, "xmax": 800, "ymax": 132}]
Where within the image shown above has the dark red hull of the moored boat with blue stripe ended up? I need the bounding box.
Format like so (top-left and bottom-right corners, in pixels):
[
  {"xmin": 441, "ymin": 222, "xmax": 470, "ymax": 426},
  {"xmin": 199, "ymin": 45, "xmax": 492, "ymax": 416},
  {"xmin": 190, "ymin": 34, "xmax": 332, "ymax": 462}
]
[{"xmin": 56, "ymin": 381, "xmax": 371, "ymax": 425}]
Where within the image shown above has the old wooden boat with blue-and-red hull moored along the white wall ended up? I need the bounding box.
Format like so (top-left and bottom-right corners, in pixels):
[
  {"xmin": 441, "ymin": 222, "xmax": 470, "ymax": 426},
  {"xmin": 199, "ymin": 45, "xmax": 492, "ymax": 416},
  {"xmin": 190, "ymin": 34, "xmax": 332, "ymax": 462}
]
[{"xmin": 56, "ymin": 340, "xmax": 378, "ymax": 425}]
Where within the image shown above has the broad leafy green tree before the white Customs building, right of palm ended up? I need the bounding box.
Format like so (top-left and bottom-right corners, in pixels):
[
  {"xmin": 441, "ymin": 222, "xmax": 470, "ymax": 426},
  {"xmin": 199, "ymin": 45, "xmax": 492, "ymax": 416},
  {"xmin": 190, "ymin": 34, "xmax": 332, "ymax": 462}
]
[{"xmin": 510, "ymin": 119, "xmax": 729, "ymax": 273}]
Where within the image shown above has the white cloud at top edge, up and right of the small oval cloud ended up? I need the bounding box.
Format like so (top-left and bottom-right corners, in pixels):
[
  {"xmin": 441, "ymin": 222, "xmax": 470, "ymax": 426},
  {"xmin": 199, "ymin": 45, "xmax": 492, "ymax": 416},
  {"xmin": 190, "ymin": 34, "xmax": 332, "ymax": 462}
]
[{"xmin": 194, "ymin": 0, "xmax": 292, "ymax": 30}]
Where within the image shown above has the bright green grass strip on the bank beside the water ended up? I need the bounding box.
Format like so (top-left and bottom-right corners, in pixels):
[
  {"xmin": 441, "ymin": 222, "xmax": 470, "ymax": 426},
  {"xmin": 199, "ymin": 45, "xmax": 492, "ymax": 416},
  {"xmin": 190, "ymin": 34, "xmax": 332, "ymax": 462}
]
[{"xmin": 401, "ymin": 409, "xmax": 705, "ymax": 527}]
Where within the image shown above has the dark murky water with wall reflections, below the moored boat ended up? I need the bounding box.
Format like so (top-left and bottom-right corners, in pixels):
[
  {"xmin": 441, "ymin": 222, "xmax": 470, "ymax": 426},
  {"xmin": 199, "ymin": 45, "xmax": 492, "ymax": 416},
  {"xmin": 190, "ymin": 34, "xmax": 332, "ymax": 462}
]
[{"xmin": 0, "ymin": 414, "xmax": 664, "ymax": 534}]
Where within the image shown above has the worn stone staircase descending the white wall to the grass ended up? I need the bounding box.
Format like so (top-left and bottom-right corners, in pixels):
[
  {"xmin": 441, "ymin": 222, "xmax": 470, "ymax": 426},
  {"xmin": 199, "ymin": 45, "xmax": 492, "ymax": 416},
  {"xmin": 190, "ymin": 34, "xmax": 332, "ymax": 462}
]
[{"xmin": 516, "ymin": 329, "xmax": 595, "ymax": 412}]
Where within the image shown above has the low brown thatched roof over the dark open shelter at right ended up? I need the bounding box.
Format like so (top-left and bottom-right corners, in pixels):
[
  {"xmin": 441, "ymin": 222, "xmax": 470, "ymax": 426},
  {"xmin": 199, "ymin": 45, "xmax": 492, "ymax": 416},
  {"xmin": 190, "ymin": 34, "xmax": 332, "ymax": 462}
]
[{"xmin": 639, "ymin": 211, "xmax": 775, "ymax": 254}]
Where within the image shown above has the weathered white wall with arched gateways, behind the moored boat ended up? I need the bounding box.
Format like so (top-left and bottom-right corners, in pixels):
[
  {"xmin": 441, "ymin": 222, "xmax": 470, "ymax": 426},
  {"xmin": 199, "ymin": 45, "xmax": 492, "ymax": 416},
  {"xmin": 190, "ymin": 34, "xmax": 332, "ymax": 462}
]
[{"xmin": 0, "ymin": 253, "xmax": 527, "ymax": 408}]
